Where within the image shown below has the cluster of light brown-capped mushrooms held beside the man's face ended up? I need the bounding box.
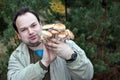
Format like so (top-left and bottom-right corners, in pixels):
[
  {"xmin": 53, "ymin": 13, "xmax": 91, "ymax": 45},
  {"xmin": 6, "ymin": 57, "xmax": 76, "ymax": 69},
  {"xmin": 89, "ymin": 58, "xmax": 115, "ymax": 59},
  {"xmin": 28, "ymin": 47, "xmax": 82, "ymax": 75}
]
[{"xmin": 41, "ymin": 23, "xmax": 74, "ymax": 42}]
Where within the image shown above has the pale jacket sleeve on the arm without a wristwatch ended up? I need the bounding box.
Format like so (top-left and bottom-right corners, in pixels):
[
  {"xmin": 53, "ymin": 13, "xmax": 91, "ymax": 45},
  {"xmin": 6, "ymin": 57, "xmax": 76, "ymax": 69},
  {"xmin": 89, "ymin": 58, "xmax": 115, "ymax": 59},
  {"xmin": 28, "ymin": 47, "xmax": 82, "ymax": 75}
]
[{"xmin": 7, "ymin": 53, "xmax": 47, "ymax": 80}]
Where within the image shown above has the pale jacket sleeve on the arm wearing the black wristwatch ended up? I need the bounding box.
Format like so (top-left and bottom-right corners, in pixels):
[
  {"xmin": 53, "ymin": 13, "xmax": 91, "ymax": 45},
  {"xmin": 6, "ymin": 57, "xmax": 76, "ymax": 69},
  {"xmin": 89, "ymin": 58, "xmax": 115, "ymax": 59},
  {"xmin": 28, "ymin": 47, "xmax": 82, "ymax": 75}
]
[{"xmin": 67, "ymin": 41, "xmax": 94, "ymax": 80}]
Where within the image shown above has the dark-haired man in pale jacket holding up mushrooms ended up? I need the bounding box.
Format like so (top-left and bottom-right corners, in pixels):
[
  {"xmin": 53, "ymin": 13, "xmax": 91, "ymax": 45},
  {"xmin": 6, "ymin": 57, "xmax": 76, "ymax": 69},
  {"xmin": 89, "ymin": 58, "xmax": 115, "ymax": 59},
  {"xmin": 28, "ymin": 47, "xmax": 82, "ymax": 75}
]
[{"xmin": 8, "ymin": 7, "xmax": 93, "ymax": 80}]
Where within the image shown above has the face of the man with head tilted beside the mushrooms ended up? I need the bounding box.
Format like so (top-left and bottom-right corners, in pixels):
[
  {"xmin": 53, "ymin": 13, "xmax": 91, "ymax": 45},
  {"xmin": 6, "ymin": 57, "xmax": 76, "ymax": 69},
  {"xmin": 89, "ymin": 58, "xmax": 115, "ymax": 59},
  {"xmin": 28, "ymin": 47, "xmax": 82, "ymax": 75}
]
[{"xmin": 16, "ymin": 12, "xmax": 42, "ymax": 47}]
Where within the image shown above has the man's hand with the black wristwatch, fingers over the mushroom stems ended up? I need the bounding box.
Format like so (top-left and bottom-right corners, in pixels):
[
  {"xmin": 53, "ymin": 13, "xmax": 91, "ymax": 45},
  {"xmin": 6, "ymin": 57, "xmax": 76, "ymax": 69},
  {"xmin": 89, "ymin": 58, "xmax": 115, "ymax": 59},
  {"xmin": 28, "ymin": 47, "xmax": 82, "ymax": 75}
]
[{"xmin": 47, "ymin": 38, "xmax": 74, "ymax": 60}]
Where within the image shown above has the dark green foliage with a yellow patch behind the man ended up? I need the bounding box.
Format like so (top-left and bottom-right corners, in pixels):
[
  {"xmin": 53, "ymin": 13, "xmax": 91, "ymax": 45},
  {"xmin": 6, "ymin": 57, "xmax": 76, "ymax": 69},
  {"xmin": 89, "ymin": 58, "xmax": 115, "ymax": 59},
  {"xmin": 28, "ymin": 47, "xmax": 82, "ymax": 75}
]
[{"xmin": 0, "ymin": 0, "xmax": 120, "ymax": 80}]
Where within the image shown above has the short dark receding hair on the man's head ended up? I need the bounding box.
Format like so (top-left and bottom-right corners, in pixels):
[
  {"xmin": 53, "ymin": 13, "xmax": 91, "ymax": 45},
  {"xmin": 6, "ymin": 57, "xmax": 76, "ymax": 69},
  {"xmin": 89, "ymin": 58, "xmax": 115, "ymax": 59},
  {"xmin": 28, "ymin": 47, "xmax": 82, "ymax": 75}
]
[{"xmin": 13, "ymin": 6, "xmax": 40, "ymax": 32}]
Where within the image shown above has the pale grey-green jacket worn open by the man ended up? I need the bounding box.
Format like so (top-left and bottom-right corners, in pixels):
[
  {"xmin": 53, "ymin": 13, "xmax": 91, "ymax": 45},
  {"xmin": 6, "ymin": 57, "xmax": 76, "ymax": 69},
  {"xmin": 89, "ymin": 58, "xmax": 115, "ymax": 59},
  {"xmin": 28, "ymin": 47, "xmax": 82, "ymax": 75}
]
[{"xmin": 7, "ymin": 40, "xmax": 93, "ymax": 80}]
